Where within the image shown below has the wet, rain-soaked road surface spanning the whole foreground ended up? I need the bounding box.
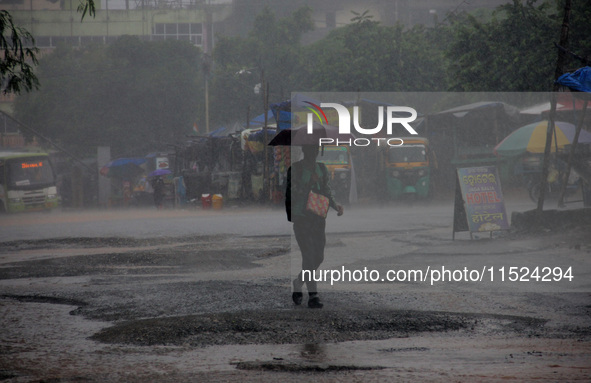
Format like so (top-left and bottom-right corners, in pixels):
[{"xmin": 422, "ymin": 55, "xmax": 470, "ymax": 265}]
[{"xmin": 0, "ymin": 199, "xmax": 591, "ymax": 383}]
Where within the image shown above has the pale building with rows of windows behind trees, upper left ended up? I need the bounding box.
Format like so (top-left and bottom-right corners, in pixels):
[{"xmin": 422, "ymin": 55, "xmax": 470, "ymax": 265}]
[{"xmin": 0, "ymin": 0, "xmax": 232, "ymax": 50}]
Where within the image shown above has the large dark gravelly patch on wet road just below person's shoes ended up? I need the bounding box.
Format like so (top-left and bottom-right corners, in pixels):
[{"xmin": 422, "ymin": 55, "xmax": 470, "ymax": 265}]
[{"xmin": 92, "ymin": 309, "xmax": 473, "ymax": 348}]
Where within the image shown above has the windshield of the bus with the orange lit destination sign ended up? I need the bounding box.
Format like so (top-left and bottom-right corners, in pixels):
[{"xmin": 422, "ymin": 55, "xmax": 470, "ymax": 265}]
[{"xmin": 7, "ymin": 157, "xmax": 54, "ymax": 189}]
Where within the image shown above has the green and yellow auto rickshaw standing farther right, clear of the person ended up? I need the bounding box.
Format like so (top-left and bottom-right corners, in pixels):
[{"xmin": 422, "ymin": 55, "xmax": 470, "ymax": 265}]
[{"xmin": 384, "ymin": 137, "xmax": 434, "ymax": 199}]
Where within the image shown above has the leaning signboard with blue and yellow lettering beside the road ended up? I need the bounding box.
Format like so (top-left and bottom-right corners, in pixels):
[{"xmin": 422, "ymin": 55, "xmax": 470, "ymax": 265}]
[{"xmin": 454, "ymin": 166, "xmax": 509, "ymax": 236}]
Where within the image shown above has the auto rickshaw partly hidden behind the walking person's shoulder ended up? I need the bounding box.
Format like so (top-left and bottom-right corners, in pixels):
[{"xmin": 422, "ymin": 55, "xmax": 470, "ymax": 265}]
[{"xmin": 318, "ymin": 145, "xmax": 351, "ymax": 202}]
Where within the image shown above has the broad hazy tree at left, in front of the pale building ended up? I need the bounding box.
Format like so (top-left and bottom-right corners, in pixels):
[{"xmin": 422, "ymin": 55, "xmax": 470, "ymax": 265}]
[{"xmin": 15, "ymin": 36, "xmax": 203, "ymax": 155}]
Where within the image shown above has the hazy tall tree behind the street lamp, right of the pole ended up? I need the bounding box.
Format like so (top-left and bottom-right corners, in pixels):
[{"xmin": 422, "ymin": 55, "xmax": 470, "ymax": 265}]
[{"xmin": 211, "ymin": 7, "xmax": 313, "ymax": 124}]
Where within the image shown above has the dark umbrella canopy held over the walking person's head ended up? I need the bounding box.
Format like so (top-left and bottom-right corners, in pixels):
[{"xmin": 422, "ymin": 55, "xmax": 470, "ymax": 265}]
[{"xmin": 269, "ymin": 122, "xmax": 355, "ymax": 146}]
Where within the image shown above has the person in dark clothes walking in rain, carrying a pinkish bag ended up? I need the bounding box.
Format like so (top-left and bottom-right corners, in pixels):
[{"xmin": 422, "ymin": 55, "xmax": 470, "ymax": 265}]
[{"xmin": 285, "ymin": 145, "xmax": 344, "ymax": 308}]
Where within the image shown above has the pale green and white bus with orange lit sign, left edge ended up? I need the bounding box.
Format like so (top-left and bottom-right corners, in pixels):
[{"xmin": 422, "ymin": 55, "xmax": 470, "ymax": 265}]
[{"xmin": 0, "ymin": 151, "xmax": 58, "ymax": 213}]
